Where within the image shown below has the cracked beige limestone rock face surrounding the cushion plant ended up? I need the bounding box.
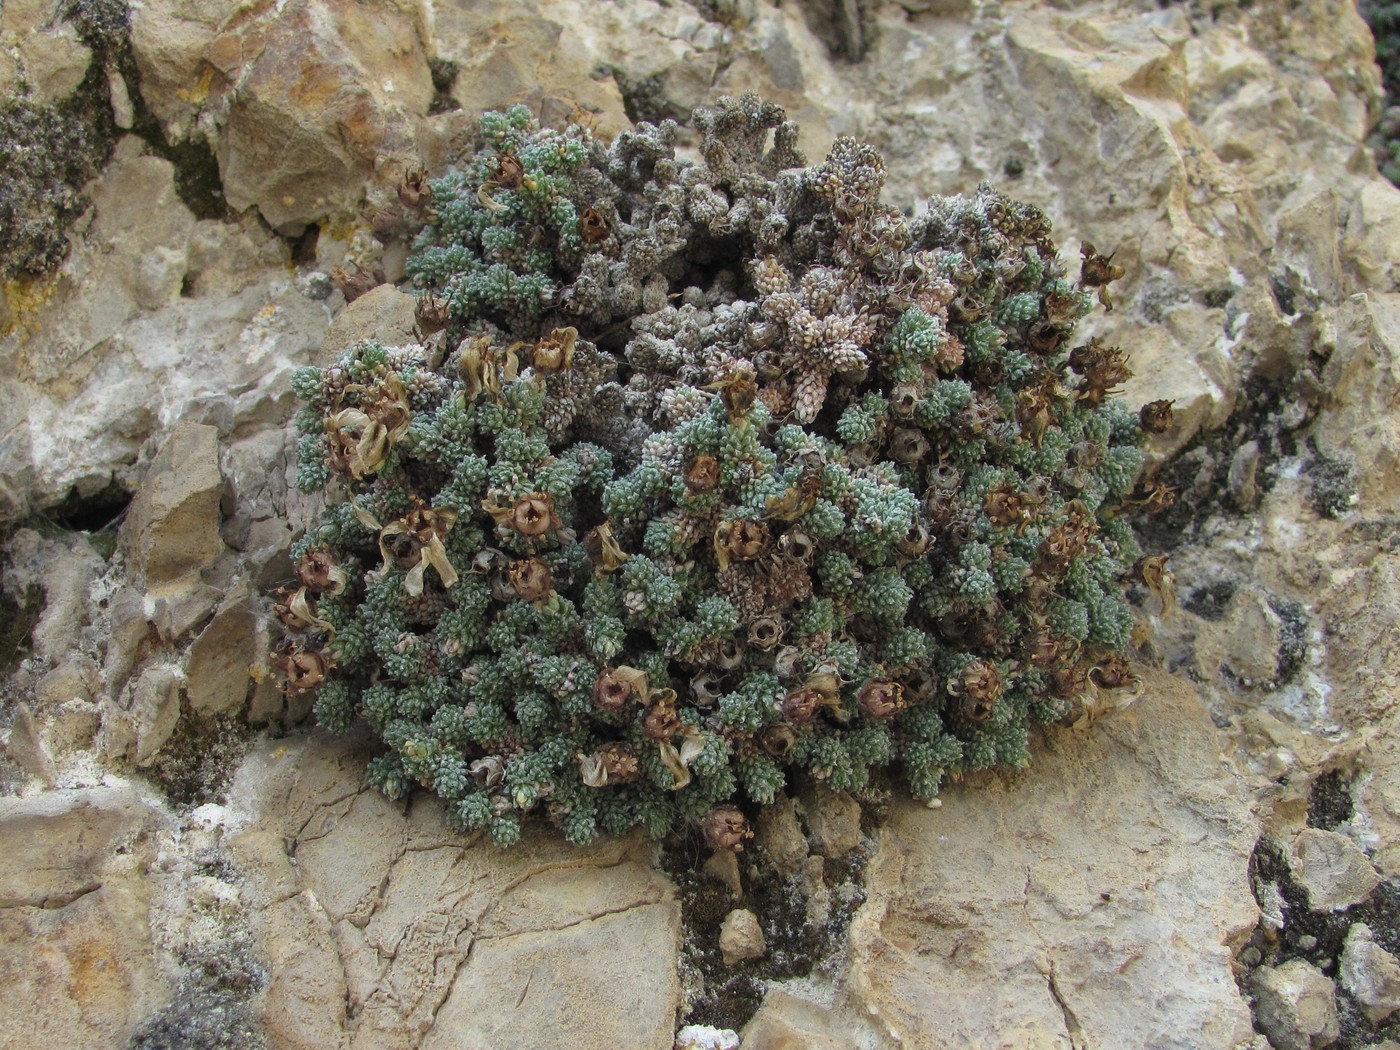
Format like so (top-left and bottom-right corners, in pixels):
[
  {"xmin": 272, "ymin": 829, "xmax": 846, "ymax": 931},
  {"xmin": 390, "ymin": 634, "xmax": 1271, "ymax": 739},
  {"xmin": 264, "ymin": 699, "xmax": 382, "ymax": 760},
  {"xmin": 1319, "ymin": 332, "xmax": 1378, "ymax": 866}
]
[{"xmin": 8, "ymin": 0, "xmax": 1400, "ymax": 1050}]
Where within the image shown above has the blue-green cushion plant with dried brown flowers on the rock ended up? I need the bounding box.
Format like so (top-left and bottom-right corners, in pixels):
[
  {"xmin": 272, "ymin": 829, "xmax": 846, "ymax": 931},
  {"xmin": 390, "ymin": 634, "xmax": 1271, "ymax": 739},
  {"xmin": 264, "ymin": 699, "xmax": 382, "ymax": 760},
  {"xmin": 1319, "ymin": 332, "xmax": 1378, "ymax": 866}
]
[{"xmin": 280, "ymin": 97, "xmax": 1170, "ymax": 848}]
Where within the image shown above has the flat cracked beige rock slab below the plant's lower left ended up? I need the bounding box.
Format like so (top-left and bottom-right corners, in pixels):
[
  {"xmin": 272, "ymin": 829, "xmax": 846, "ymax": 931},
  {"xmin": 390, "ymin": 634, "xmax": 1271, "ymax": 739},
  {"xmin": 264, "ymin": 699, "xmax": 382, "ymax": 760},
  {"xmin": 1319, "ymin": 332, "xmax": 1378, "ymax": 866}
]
[{"xmin": 232, "ymin": 735, "xmax": 679, "ymax": 1047}]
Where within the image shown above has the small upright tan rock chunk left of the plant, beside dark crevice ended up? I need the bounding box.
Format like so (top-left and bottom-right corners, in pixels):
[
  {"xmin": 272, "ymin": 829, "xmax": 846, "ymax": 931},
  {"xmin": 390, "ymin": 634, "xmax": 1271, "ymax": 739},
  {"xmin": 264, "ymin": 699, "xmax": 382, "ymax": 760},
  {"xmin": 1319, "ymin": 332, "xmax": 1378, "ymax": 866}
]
[{"xmin": 120, "ymin": 423, "xmax": 224, "ymax": 592}]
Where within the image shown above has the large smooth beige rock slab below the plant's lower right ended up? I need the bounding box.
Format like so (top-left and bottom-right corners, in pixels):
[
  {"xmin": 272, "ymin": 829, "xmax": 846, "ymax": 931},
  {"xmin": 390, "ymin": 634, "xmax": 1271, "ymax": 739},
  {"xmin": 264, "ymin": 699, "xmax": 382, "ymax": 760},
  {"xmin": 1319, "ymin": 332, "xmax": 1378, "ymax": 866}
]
[{"xmin": 851, "ymin": 672, "xmax": 1257, "ymax": 1047}]
